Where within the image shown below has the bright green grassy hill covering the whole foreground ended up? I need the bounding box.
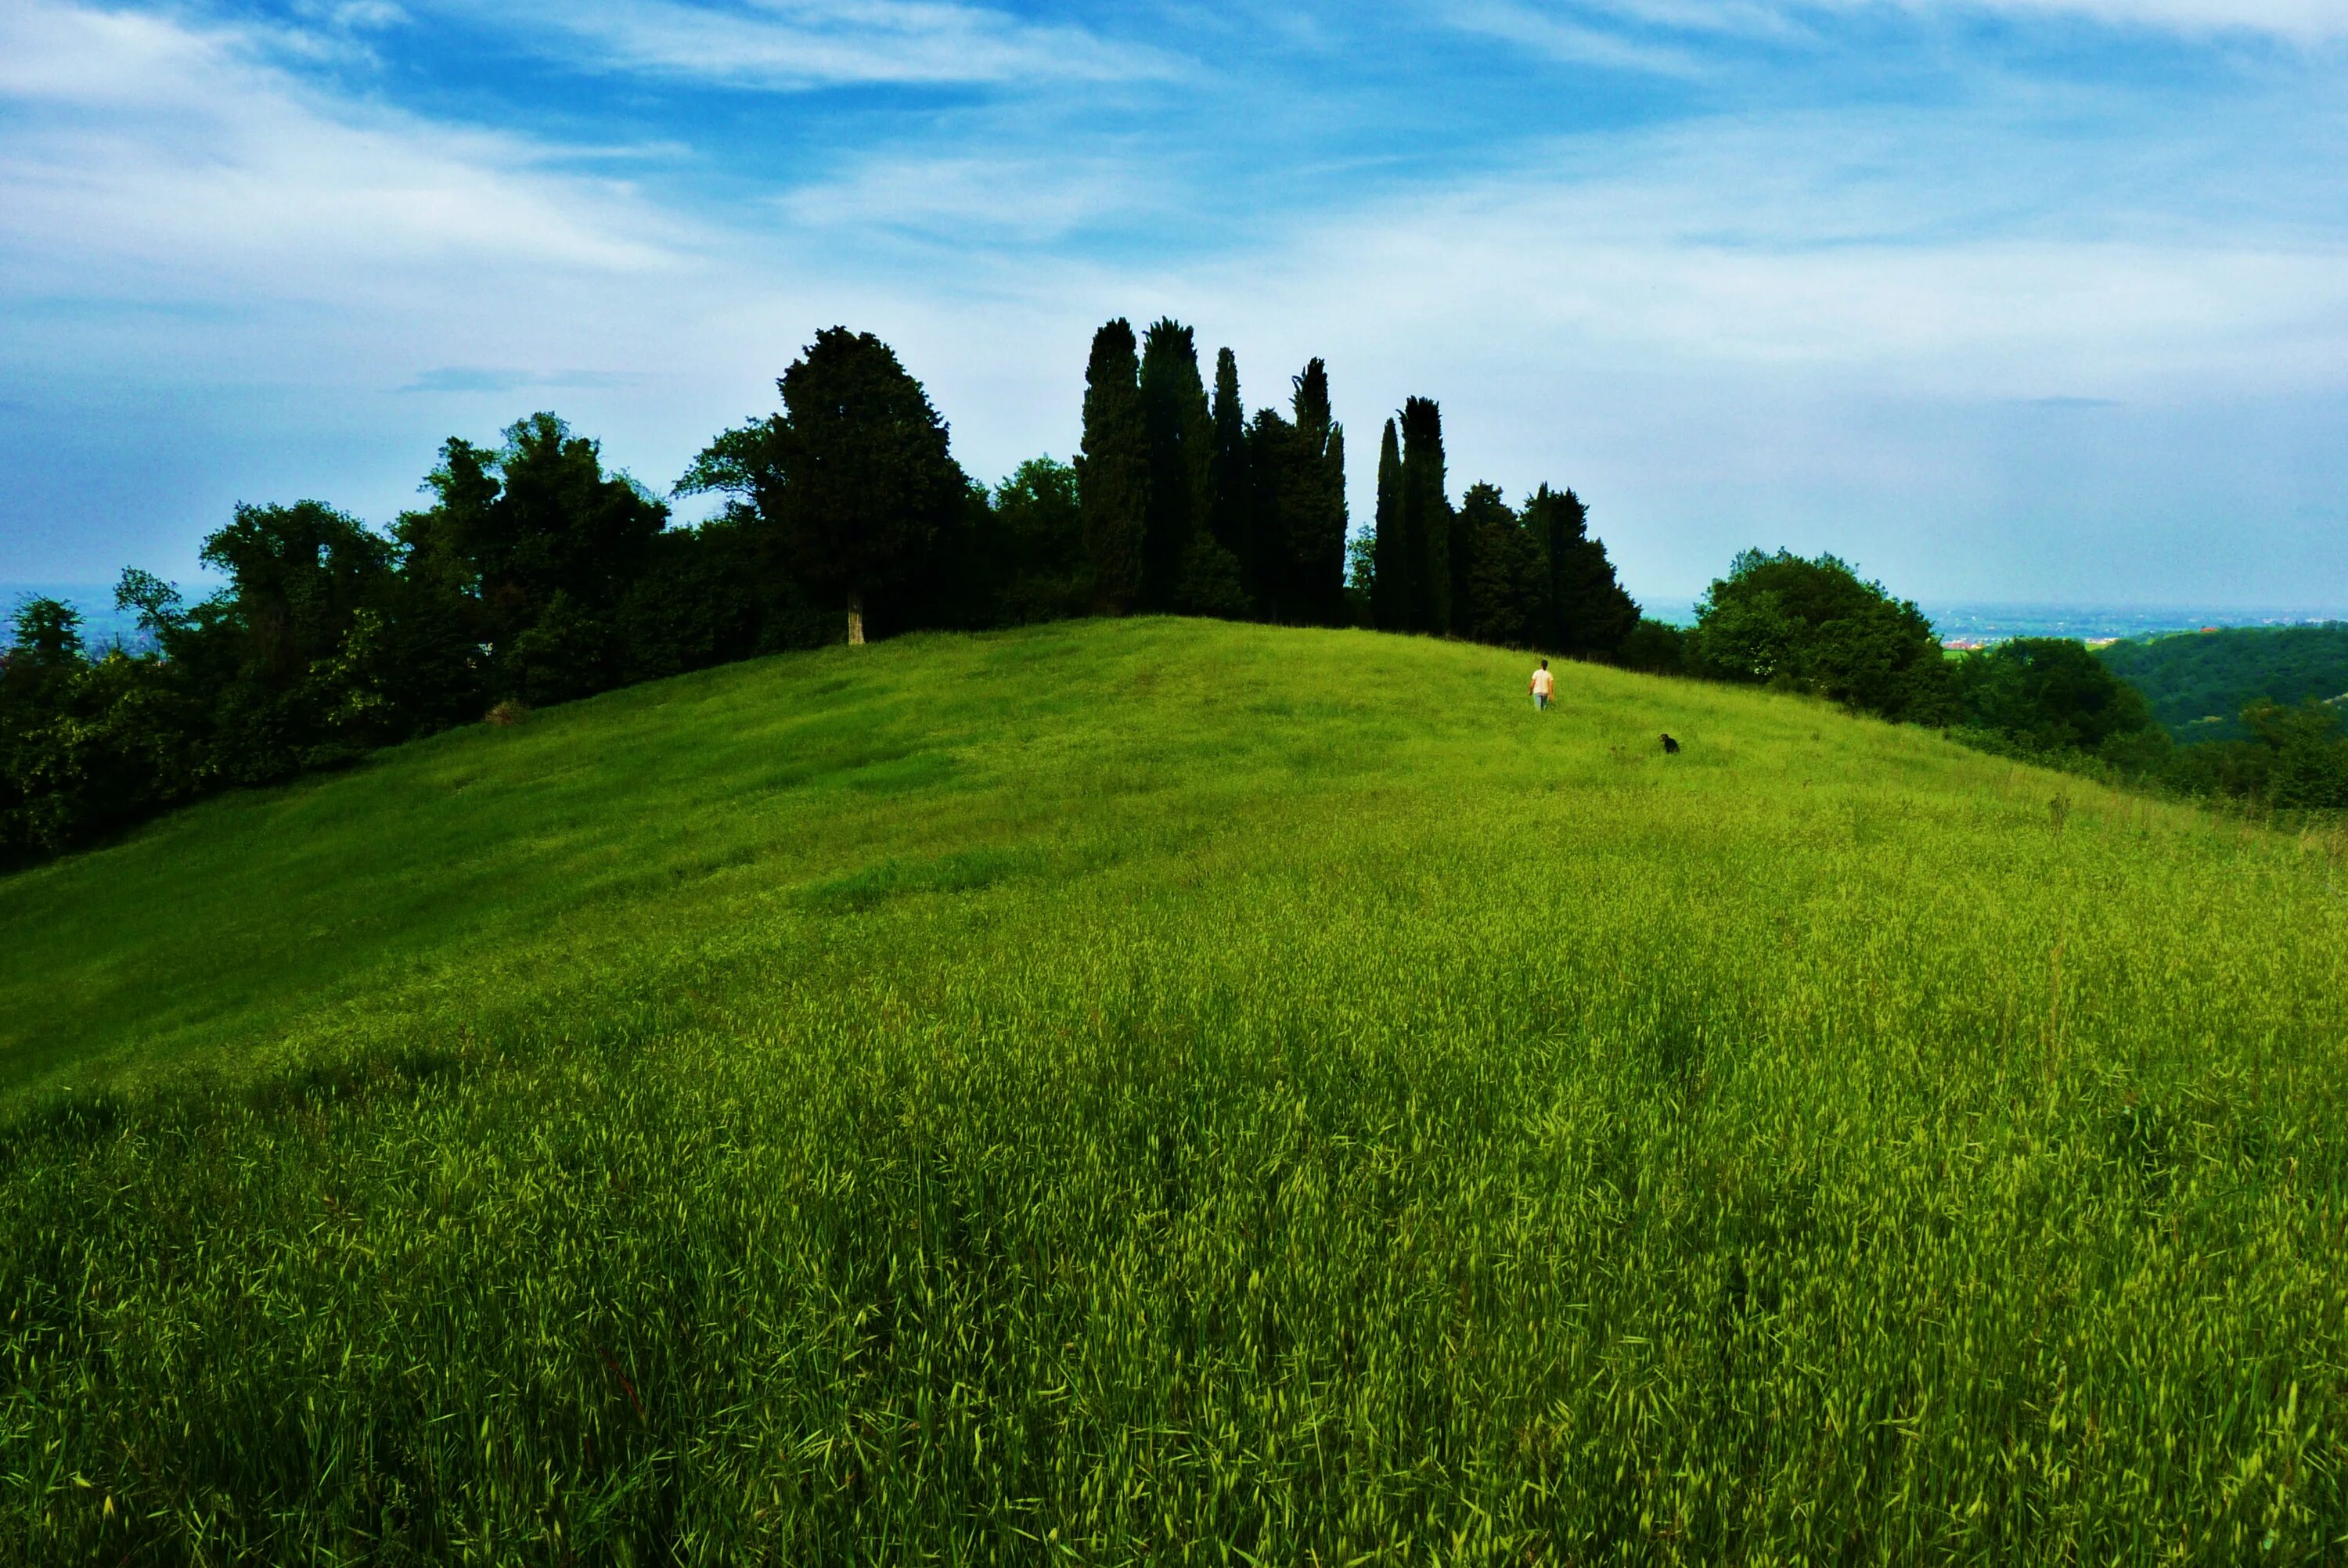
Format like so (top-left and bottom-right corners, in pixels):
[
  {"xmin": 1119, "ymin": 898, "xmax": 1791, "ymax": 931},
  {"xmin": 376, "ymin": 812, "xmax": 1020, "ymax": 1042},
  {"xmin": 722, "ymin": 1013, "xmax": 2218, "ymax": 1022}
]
[{"xmin": 0, "ymin": 620, "xmax": 2348, "ymax": 1566}]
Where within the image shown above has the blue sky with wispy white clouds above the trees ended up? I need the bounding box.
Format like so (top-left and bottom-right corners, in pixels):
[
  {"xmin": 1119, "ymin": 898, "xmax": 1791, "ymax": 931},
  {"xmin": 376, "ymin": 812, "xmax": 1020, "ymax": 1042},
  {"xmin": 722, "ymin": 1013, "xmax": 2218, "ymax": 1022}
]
[{"xmin": 0, "ymin": 0, "xmax": 2348, "ymax": 610}]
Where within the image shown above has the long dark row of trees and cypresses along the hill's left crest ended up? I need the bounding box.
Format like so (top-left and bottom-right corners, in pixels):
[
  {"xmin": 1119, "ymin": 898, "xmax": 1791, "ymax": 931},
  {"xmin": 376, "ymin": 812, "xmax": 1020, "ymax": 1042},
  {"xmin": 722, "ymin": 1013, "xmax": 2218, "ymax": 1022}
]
[{"xmin": 0, "ymin": 319, "xmax": 1639, "ymax": 864}]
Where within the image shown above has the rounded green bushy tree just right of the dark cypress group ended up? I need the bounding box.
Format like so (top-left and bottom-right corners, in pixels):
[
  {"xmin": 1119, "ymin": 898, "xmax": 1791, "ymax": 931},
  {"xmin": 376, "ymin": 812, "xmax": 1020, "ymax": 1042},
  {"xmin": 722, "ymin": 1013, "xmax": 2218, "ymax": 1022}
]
[{"xmin": 1688, "ymin": 549, "xmax": 1956, "ymax": 725}]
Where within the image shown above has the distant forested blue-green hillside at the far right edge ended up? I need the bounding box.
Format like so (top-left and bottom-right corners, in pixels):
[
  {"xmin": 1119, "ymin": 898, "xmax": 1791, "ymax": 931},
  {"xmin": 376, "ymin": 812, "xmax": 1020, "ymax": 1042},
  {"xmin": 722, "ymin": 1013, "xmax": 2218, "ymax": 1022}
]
[{"xmin": 2101, "ymin": 622, "xmax": 2348, "ymax": 739}]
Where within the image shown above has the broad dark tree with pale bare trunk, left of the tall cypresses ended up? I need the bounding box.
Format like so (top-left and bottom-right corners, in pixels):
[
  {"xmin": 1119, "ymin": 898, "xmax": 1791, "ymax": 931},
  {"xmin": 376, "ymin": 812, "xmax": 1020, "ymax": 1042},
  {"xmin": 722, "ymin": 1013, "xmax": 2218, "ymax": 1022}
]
[{"xmin": 679, "ymin": 326, "xmax": 970, "ymax": 646}]
